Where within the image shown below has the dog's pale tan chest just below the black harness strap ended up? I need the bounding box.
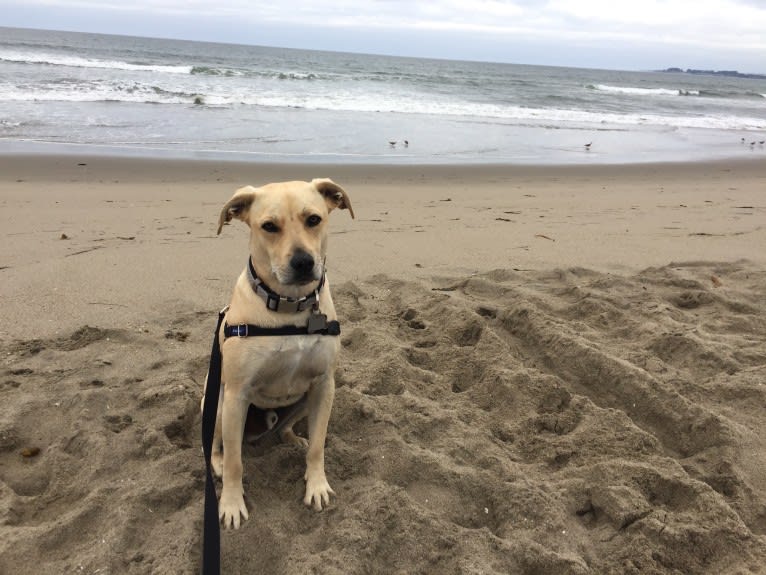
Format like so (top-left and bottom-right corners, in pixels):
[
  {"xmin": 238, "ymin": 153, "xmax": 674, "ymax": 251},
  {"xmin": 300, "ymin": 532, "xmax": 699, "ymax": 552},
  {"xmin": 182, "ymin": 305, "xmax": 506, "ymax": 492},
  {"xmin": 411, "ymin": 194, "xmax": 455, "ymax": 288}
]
[{"xmin": 230, "ymin": 335, "xmax": 337, "ymax": 408}]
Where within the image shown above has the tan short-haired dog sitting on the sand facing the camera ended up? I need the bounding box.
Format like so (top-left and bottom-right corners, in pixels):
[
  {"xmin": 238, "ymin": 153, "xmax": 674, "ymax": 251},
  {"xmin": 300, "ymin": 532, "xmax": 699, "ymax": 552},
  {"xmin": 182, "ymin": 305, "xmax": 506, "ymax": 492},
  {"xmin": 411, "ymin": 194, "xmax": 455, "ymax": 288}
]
[{"xmin": 203, "ymin": 179, "xmax": 354, "ymax": 529}]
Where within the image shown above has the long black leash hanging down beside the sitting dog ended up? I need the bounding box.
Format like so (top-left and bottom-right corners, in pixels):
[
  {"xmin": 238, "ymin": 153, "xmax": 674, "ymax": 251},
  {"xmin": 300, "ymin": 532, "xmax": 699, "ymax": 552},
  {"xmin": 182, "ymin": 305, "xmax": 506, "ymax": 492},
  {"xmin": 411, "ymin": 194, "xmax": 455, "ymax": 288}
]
[{"xmin": 202, "ymin": 308, "xmax": 227, "ymax": 575}]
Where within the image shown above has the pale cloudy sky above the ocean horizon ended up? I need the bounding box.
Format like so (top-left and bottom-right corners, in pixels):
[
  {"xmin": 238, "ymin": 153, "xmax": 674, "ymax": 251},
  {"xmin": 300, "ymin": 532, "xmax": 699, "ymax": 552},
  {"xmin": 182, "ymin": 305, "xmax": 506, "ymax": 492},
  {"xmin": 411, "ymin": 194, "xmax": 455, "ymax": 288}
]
[{"xmin": 0, "ymin": 0, "xmax": 766, "ymax": 73}]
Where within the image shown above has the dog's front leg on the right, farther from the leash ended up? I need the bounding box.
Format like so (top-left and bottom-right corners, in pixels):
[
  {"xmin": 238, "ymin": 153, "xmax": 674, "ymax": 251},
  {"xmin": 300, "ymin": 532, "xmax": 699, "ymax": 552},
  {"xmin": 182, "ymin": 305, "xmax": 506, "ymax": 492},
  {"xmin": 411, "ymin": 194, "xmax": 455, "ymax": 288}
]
[{"xmin": 303, "ymin": 375, "xmax": 335, "ymax": 511}]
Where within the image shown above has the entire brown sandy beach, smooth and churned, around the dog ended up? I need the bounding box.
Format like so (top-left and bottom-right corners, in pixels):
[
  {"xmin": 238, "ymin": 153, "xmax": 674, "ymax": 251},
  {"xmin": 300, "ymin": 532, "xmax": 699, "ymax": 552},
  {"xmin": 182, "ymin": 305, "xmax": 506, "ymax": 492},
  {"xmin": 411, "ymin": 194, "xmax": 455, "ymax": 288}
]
[{"xmin": 0, "ymin": 155, "xmax": 766, "ymax": 575}]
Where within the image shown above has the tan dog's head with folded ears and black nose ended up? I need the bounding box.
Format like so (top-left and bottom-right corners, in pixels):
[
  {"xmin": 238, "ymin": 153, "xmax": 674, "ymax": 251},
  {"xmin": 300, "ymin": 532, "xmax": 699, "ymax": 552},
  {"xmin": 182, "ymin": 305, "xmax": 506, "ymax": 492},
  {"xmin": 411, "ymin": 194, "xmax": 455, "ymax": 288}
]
[{"xmin": 218, "ymin": 179, "xmax": 354, "ymax": 295}]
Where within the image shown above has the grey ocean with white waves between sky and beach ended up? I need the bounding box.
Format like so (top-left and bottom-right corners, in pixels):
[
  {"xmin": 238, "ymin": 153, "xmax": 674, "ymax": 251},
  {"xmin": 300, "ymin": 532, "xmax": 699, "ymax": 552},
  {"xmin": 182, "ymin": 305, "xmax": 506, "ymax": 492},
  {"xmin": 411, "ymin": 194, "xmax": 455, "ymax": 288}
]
[{"xmin": 0, "ymin": 28, "xmax": 766, "ymax": 164}]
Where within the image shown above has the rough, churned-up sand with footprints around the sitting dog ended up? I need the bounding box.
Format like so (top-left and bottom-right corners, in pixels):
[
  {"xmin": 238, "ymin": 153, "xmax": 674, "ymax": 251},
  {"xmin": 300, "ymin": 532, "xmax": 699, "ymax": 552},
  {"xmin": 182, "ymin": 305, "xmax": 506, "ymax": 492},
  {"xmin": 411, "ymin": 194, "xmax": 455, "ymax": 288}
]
[{"xmin": 0, "ymin": 262, "xmax": 766, "ymax": 575}]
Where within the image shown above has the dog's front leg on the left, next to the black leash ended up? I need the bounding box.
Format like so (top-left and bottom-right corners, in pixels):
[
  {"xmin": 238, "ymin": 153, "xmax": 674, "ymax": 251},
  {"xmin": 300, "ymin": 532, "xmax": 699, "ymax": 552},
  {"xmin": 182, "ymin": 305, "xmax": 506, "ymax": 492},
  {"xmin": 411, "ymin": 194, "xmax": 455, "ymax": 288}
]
[{"xmin": 218, "ymin": 388, "xmax": 250, "ymax": 529}]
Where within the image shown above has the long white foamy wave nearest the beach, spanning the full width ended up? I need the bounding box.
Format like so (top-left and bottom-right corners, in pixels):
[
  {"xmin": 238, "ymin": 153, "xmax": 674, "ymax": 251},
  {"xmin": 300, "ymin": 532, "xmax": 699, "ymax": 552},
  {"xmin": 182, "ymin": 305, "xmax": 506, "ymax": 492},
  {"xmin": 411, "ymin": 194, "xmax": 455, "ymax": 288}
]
[{"xmin": 0, "ymin": 75, "xmax": 766, "ymax": 130}]
